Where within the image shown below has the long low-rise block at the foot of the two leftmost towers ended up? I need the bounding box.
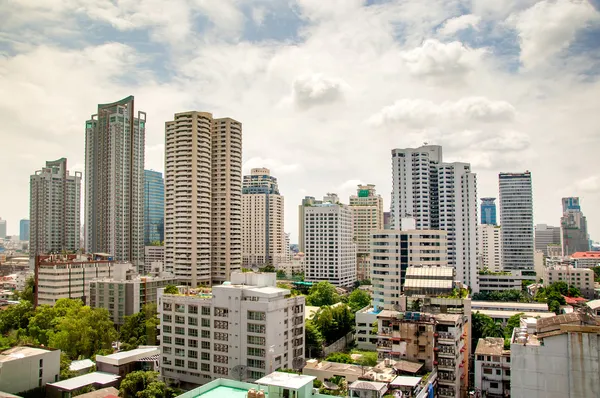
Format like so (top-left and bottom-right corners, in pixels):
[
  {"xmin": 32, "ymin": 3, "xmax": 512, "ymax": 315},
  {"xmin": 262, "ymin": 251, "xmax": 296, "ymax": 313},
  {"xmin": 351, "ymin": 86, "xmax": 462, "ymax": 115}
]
[{"xmin": 34, "ymin": 254, "xmax": 116, "ymax": 306}]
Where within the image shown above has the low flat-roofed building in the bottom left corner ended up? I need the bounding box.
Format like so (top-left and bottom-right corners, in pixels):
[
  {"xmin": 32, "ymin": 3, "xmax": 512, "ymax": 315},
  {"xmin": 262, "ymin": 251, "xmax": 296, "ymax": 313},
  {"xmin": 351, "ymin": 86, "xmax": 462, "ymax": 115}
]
[{"xmin": 0, "ymin": 347, "xmax": 60, "ymax": 394}]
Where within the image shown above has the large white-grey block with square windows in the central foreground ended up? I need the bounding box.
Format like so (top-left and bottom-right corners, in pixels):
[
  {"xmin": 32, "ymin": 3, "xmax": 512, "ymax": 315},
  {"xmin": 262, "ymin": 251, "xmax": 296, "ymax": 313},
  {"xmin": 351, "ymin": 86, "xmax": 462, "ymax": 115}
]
[{"xmin": 158, "ymin": 272, "xmax": 305, "ymax": 384}]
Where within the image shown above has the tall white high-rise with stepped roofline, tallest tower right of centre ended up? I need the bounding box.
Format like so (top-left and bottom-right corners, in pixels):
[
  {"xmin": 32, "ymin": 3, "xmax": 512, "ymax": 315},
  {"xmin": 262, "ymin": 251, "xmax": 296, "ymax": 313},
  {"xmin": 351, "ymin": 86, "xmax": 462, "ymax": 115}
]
[{"xmin": 391, "ymin": 145, "xmax": 478, "ymax": 291}]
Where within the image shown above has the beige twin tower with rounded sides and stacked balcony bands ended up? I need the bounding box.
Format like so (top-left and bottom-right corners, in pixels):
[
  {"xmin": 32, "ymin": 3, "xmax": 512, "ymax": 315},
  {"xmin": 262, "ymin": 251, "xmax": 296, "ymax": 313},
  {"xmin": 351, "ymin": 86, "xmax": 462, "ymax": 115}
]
[{"xmin": 165, "ymin": 112, "xmax": 242, "ymax": 286}]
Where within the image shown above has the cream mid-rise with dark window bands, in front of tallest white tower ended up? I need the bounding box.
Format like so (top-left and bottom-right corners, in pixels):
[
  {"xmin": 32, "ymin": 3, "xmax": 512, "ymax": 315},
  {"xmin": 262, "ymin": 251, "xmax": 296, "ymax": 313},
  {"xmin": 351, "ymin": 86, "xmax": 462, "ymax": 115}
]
[{"xmin": 371, "ymin": 230, "xmax": 448, "ymax": 310}]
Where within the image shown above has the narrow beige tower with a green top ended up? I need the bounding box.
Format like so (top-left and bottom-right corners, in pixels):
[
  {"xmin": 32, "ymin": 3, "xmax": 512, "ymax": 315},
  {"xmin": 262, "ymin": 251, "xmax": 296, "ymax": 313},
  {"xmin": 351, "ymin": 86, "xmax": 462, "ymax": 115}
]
[{"xmin": 350, "ymin": 184, "xmax": 383, "ymax": 280}]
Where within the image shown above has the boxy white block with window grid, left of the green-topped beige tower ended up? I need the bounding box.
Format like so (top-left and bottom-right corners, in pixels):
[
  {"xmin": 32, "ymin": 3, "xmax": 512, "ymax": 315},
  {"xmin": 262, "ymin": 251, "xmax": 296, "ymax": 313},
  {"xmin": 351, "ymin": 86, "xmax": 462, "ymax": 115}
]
[{"xmin": 303, "ymin": 198, "xmax": 356, "ymax": 287}]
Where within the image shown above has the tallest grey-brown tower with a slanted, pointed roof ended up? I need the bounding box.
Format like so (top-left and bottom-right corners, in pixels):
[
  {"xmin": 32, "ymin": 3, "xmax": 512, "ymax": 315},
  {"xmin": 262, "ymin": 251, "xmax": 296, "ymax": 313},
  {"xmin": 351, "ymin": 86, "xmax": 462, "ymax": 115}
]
[{"xmin": 85, "ymin": 96, "xmax": 146, "ymax": 267}]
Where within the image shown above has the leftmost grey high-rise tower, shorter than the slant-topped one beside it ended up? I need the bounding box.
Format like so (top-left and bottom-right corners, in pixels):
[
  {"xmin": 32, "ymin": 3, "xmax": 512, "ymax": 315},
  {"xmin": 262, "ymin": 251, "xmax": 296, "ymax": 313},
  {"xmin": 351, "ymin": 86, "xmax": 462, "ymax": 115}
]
[{"xmin": 29, "ymin": 158, "xmax": 81, "ymax": 257}]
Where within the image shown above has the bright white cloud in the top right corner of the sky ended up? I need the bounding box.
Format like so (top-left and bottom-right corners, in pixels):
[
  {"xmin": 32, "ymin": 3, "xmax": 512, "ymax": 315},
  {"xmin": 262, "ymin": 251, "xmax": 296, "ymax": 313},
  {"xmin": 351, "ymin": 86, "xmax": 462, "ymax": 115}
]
[{"xmin": 507, "ymin": 0, "xmax": 600, "ymax": 68}]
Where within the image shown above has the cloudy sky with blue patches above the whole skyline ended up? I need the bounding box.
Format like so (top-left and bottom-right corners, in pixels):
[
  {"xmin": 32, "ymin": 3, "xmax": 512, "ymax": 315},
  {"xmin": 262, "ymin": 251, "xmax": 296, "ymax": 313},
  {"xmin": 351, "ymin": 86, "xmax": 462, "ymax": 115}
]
[{"xmin": 0, "ymin": 0, "xmax": 600, "ymax": 242}]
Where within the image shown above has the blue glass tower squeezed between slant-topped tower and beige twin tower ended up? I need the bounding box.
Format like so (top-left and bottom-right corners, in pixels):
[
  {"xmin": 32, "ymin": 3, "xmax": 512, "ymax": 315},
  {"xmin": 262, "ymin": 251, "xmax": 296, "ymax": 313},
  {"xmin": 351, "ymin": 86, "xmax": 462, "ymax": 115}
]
[{"xmin": 144, "ymin": 170, "xmax": 165, "ymax": 246}]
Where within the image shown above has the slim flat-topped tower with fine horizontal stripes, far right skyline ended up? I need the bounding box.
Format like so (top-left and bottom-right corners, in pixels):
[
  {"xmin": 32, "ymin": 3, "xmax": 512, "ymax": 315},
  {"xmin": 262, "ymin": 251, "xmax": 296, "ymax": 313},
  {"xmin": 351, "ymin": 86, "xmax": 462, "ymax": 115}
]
[{"xmin": 499, "ymin": 171, "xmax": 534, "ymax": 271}]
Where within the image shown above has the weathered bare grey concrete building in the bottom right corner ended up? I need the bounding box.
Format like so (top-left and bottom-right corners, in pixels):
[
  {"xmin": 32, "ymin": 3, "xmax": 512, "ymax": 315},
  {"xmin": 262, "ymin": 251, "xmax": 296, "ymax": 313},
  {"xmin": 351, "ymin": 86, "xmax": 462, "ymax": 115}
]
[{"xmin": 510, "ymin": 312, "xmax": 600, "ymax": 398}]
